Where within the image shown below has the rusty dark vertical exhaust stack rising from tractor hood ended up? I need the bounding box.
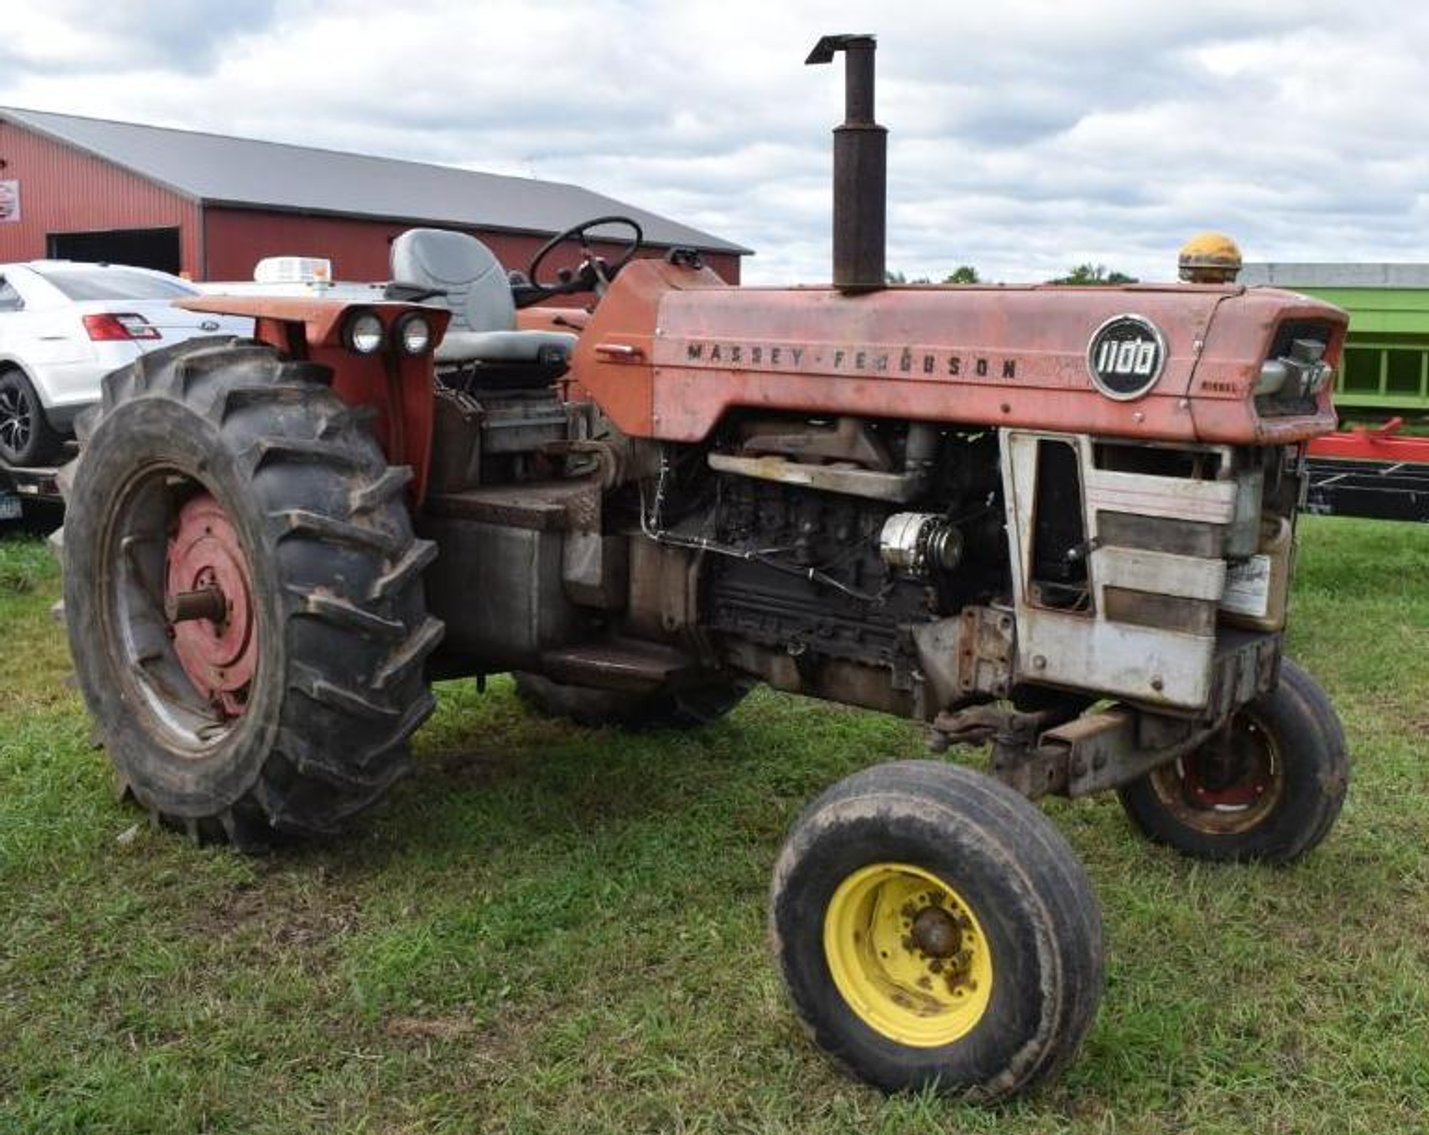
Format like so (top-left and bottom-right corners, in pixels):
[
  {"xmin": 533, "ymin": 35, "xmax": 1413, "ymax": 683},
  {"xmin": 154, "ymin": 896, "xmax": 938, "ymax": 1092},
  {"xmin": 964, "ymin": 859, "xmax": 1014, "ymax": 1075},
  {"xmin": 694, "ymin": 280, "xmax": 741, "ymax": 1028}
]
[{"xmin": 805, "ymin": 36, "xmax": 889, "ymax": 292}]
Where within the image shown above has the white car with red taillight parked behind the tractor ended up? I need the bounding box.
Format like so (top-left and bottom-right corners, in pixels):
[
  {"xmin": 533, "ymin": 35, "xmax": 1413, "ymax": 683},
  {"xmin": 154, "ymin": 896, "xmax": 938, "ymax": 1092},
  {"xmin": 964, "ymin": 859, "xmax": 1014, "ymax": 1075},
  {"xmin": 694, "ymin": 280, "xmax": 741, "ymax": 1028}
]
[{"xmin": 0, "ymin": 260, "xmax": 253, "ymax": 465}]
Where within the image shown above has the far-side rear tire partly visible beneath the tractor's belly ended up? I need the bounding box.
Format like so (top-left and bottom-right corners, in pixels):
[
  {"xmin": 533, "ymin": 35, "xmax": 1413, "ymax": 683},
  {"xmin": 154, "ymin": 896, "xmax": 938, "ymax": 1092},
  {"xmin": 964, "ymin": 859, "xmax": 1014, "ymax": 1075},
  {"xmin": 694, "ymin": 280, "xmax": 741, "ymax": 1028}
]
[{"xmin": 513, "ymin": 670, "xmax": 752, "ymax": 729}]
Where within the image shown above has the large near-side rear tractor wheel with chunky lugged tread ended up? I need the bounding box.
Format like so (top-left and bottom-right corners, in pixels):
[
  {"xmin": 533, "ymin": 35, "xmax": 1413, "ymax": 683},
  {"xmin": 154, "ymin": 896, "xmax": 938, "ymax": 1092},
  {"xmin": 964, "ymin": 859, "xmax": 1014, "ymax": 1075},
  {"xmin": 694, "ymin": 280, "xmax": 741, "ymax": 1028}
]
[{"xmin": 63, "ymin": 340, "xmax": 442, "ymax": 846}]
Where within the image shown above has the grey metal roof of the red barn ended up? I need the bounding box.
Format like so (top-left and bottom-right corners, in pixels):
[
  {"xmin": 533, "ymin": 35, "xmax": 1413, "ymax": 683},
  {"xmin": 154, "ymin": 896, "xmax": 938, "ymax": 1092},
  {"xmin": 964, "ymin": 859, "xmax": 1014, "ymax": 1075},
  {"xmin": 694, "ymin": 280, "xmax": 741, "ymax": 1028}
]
[{"xmin": 0, "ymin": 107, "xmax": 752, "ymax": 254}]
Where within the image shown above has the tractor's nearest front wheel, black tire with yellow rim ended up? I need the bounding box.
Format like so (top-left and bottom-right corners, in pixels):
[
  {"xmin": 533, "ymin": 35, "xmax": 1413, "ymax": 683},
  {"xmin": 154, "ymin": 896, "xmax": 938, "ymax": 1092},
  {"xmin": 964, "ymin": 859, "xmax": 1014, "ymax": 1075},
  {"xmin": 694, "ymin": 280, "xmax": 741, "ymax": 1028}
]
[{"xmin": 769, "ymin": 760, "xmax": 1105, "ymax": 1101}]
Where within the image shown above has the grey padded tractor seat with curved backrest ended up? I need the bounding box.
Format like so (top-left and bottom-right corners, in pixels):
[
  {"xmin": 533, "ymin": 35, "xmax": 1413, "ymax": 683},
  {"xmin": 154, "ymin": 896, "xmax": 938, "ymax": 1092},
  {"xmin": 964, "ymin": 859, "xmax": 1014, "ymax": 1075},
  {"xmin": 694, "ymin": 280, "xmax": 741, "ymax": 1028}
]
[{"xmin": 392, "ymin": 229, "xmax": 576, "ymax": 369}]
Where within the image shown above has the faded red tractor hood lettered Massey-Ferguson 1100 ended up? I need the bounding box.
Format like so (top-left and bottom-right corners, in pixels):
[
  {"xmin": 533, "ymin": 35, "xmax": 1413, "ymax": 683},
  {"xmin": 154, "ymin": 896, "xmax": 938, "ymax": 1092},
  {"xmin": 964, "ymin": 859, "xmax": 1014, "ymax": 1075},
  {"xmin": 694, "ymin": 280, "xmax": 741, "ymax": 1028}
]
[{"xmin": 574, "ymin": 260, "xmax": 1348, "ymax": 445}]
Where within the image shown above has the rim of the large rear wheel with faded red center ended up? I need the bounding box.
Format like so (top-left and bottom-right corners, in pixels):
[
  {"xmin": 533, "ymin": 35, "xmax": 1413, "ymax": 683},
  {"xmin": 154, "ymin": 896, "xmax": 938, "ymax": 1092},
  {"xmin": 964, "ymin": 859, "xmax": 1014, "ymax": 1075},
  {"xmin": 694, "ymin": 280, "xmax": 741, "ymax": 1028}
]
[{"xmin": 101, "ymin": 467, "xmax": 260, "ymax": 758}]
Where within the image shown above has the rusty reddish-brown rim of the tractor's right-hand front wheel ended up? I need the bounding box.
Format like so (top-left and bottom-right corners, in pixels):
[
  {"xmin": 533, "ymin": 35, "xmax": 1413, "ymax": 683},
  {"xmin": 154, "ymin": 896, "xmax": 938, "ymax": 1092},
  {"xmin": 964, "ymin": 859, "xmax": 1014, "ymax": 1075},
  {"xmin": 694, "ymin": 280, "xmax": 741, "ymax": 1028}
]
[{"xmin": 1150, "ymin": 709, "xmax": 1285, "ymax": 835}]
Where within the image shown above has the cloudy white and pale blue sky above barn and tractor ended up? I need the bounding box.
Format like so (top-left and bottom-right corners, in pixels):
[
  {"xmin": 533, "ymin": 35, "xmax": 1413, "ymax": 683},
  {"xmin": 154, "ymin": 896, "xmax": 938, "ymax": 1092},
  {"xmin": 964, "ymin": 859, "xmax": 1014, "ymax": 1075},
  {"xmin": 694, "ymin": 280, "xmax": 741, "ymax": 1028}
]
[{"xmin": 0, "ymin": 0, "xmax": 1429, "ymax": 283}]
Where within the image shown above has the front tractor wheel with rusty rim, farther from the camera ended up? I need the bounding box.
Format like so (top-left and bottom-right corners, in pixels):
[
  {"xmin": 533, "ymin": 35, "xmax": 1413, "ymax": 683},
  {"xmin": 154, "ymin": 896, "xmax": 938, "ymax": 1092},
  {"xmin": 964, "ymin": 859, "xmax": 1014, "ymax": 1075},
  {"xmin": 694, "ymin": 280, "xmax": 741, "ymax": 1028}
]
[{"xmin": 1119, "ymin": 659, "xmax": 1349, "ymax": 863}]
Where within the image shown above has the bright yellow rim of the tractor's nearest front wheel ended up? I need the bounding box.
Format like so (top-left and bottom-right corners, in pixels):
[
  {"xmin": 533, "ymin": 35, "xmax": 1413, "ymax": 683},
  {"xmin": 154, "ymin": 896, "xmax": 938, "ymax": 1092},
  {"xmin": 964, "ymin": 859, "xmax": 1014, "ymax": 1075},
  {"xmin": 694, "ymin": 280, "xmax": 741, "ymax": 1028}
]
[{"xmin": 823, "ymin": 863, "xmax": 993, "ymax": 1048}]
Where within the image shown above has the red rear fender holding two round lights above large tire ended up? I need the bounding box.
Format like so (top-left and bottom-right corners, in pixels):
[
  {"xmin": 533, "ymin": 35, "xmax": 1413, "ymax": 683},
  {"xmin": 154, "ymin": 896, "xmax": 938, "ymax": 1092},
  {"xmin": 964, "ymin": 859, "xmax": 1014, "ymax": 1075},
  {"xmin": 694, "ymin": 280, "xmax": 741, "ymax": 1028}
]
[{"xmin": 176, "ymin": 294, "xmax": 452, "ymax": 505}]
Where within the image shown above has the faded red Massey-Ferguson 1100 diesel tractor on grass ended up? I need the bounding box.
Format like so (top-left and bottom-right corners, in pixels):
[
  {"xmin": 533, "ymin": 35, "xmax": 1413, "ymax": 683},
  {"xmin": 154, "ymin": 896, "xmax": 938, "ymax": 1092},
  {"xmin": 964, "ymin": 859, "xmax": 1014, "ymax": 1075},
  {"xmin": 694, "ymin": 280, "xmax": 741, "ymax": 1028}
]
[{"xmin": 55, "ymin": 36, "xmax": 1348, "ymax": 1099}]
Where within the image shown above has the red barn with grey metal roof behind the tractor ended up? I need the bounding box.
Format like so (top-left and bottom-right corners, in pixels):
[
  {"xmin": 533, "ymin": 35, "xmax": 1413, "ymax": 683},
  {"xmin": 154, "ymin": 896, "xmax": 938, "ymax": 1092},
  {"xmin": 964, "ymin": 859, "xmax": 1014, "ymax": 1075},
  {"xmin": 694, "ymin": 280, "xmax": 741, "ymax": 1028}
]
[{"xmin": 0, "ymin": 107, "xmax": 750, "ymax": 283}]
